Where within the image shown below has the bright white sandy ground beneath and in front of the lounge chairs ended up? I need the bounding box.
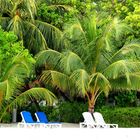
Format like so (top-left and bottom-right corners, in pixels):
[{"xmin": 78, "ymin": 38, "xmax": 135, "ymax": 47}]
[{"xmin": 0, "ymin": 123, "xmax": 140, "ymax": 140}]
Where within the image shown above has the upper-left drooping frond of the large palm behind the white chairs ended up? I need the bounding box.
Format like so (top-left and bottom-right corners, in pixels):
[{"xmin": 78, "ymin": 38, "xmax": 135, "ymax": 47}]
[{"xmin": 63, "ymin": 19, "xmax": 89, "ymax": 61}]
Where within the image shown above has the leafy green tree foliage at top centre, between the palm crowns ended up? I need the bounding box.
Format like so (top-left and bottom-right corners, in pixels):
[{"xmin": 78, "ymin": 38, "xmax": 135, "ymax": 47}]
[{"xmin": 37, "ymin": 0, "xmax": 96, "ymax": 29}]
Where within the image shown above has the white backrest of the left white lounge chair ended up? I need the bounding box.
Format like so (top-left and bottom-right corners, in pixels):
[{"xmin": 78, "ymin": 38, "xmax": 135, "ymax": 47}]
[{"xmin": 82, "ymin": 112, "xmax": 95, "ymax": 124}]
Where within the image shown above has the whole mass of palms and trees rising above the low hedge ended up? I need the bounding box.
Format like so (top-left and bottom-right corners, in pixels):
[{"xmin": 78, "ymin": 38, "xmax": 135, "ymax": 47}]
[{"xmin": 0, "ymin": 0, "xmax": 140, "ymax": 124}]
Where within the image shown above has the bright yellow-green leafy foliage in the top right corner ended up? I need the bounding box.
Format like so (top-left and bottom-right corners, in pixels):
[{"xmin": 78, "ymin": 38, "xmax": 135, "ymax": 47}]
[{"xmin": 97, "ymin": 0, "xmax": 140, "ymax": 39}]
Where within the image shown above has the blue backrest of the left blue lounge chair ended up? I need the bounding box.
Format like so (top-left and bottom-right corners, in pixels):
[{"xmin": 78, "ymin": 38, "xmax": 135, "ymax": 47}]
[{"xmin": 20, "ymin": 111, "xmax": 34, "ymax": 123}]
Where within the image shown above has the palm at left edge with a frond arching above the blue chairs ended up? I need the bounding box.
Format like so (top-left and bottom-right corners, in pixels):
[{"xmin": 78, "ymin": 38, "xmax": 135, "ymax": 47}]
[{"xmin": 0, "ymin": 51, "xmax": 57, "ymax": 121}]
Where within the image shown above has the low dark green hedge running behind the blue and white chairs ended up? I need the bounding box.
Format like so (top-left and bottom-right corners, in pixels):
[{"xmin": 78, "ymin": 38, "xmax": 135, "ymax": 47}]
[{"xmin": 17, "ymin": 102, "xmax": 140, "ymax": 128}]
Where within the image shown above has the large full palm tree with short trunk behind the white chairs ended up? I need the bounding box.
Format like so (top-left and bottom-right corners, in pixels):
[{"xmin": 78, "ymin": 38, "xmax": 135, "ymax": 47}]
[{"xmin": 36, "ymin": 15, "xmax": 140, "ymax": 112}]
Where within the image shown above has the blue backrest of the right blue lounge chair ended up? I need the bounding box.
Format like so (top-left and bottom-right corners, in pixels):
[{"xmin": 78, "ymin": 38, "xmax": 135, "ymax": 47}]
[{"xmin": 35, "ymin": 112, "xmax": 49, "ymax": 123}]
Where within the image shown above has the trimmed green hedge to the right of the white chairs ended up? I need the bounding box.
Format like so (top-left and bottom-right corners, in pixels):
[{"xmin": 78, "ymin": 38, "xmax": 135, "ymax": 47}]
[{"xmin": 96, "ymin": 107, "xmax": 140, "ymax": 128}]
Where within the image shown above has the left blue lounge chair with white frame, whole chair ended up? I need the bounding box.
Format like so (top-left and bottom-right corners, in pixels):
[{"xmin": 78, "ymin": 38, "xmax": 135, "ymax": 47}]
[{"xmin": 18, "ymin": 111, "xmax": 44, "ymax": 127}]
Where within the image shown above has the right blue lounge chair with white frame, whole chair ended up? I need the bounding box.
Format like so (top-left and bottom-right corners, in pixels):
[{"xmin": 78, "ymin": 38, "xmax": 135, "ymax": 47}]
[{"xmin": 35, "ymin": 112, "xmax": 62, "ymax": 128}]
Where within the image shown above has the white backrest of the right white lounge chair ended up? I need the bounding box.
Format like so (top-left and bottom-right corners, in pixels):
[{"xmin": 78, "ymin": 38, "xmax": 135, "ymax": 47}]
[{"xmin": 93, "ymin": 112, "xmax": 106, "ymax": 124}]
